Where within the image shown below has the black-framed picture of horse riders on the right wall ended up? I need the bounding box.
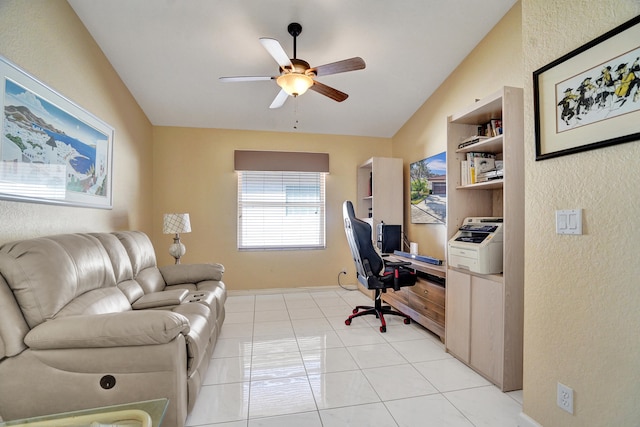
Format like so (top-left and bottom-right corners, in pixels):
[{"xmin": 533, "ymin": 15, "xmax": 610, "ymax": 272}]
[{"xmin": 533, "ymin": 16, "xmax": 640, "ymax": 160}]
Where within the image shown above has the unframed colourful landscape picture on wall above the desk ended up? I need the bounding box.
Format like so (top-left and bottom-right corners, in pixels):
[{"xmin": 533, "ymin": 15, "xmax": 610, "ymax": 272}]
[{"xmin": 409, "ymin": 151, "xmax": 447, "ymax": 224}]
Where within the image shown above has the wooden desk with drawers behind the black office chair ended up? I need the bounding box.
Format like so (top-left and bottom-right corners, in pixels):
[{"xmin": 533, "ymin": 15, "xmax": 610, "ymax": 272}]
[{"xmin": 382, "ymin": 255, "xmax": 447, "ymax": 342}]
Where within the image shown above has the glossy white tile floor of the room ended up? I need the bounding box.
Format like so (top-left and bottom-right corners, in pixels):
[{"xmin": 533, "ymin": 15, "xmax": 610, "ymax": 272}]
[{"xmin": 187, "ymin": 288, "xmax": 522, "ymax": 427}]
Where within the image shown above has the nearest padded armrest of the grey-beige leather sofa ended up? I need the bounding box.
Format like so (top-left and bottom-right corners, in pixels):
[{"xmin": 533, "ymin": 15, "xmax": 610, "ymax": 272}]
[{"xmin": 24, "ymin": 310, "xmax": 189, "ymax": 350}]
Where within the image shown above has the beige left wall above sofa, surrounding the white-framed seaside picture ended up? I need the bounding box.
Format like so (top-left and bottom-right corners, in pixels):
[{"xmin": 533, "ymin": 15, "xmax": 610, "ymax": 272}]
[{"xmin": 0, "ymin": 0, "xmax": 152, "ymax": 242}]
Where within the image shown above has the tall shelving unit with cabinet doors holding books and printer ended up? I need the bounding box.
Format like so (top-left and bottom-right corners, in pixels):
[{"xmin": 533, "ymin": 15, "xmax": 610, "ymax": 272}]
[{"xmin": 445, "ymin": 87, "xmax": 524, "ymax": 391}]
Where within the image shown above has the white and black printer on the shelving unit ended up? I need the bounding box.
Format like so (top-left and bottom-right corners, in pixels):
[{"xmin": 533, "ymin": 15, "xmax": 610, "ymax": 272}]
[{"xmin": 447, "ymin": 217, "xmax": 503, "ymax": 274}]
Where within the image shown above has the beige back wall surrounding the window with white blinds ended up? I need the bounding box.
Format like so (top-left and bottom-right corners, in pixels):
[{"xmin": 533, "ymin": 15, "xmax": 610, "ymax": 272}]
[{"xmin": 153, "ymin": 127, "xmax": 391, "ymax": 290}]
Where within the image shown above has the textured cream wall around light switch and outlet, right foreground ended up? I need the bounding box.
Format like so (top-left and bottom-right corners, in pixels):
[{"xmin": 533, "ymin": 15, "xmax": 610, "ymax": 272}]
[{"xmin": 522, "ymin": 0, "xmax": 640, "ymax": 427}]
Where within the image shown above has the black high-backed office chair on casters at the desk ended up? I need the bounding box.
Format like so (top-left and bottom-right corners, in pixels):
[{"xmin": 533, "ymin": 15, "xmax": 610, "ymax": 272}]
[{"xmin": 342, "ymin": 200, "xmax": 416, "ymax": 332}]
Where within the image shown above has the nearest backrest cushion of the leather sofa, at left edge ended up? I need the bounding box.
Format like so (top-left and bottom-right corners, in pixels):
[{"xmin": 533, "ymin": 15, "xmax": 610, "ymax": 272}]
[{"xmin": 0, "ymin": 234, "xmax": 115, "ymax": 328}]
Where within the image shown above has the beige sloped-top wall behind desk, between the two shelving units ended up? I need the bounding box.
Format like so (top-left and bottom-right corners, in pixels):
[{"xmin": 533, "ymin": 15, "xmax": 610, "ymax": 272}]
[{"xmin": 393, "ymin": 2, "xmax": 524, "ymax": 259}]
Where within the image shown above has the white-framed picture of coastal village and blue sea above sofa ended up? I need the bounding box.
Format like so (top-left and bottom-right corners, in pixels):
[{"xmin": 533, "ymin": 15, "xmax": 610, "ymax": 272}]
[{"xmin": 0, "ymin": 56, "xmax": 114, "ymax": 209}]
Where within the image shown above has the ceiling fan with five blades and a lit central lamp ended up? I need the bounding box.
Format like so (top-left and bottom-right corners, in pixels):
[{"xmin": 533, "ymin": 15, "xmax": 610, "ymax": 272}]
[{"xmin": 220, "ymin": 22, "xmax": 366, "ymax": 108}]
